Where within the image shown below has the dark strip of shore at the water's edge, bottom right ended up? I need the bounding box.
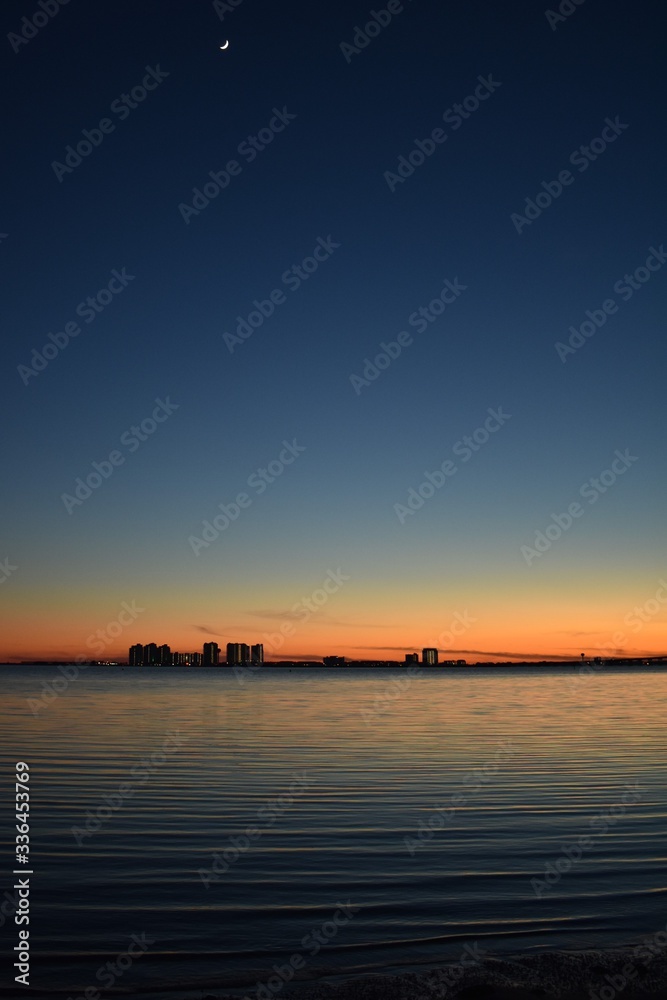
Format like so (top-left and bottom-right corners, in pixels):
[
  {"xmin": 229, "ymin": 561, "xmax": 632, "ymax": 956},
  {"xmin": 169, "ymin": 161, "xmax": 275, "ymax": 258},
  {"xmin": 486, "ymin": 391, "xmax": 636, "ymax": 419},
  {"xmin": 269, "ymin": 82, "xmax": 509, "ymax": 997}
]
[{"xmin": 200, "ymin": 935, "xmax": 667, "ymax": 1000}]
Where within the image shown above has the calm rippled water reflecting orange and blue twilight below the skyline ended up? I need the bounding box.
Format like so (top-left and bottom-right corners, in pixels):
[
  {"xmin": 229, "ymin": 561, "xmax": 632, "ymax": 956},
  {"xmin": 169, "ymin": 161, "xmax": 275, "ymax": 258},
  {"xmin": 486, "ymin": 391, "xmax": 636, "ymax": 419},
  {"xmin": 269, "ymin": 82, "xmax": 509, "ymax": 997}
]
[{"xmin": 0, "ymin": 667, "xmax": 667, "ymax": 997}]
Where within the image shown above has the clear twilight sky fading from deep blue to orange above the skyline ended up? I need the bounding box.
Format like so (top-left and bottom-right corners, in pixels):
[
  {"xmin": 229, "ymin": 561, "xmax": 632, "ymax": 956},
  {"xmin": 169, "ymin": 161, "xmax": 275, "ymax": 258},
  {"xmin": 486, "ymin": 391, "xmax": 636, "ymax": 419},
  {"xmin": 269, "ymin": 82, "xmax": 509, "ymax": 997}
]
[{"xmin": 0, "ymin": 0, "xmax": 667, "ymax": 660}]
